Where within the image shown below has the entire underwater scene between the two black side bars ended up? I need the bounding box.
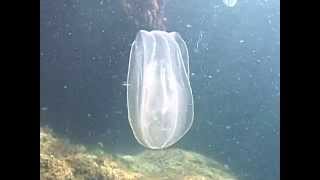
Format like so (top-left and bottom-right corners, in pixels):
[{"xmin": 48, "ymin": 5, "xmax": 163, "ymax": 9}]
[{"xmin": 40, "ymin": 0, "xmax": 280, "ymax": 180}]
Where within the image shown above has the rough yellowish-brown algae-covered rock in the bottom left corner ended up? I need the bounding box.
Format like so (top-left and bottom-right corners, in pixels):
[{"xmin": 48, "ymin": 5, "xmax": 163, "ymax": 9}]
[{"xmin": 40, "ymin": 128, "xmax": 142, "ymax": 180}]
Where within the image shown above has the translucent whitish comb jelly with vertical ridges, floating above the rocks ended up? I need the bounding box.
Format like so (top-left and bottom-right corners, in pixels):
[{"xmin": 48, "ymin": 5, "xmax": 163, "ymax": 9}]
[{"xmin": 127, "ymin": 30, "xmax": 194, "ymax": 149}]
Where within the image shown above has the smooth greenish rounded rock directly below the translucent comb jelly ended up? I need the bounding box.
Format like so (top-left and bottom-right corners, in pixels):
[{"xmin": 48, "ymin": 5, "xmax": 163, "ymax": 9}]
[{"xmin": 121, "ymin": 149, "xmax": 236, "ymax": 180}]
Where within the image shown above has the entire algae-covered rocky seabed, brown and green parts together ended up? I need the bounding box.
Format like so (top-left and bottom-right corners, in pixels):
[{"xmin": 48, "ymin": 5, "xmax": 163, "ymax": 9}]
[{"xmin": 40, "ymin": 128, "xmax": 236, "ymax": 180}]
